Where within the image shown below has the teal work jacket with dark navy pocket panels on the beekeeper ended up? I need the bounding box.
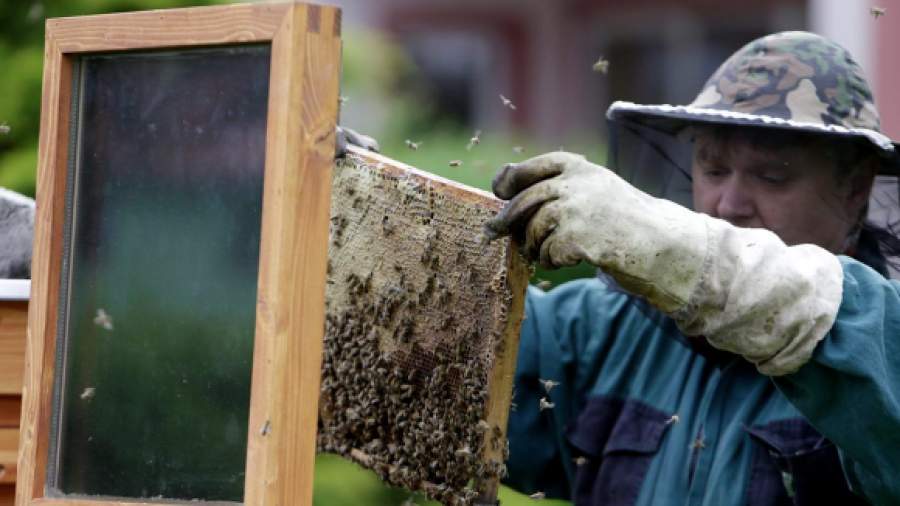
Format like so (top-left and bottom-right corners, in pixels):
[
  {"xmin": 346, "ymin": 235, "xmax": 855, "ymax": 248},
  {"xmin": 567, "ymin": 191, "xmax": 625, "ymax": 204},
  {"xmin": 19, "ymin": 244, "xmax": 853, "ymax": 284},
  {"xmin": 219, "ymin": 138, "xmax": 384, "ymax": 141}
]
[{"xmin": 506, "ymin": 257, "xmax": 900, "ymax": 505}]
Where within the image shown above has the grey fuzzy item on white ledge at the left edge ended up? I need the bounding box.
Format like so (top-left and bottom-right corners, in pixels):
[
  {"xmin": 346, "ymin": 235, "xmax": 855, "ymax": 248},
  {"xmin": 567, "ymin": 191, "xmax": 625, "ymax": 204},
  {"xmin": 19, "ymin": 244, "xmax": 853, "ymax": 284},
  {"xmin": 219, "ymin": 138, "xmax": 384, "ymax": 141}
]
[{"xmin": 0, "ymin": 188, "xmax": 34, "ymax": 279}]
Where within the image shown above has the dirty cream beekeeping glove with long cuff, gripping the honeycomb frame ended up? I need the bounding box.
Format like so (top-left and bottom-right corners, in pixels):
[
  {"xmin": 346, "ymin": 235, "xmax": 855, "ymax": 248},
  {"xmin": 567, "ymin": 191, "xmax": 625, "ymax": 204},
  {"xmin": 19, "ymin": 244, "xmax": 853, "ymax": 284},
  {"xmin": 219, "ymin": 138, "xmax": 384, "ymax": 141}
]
[{"xmin": 485, "ymin": 152, "xmax": 843, "ymax": 375}]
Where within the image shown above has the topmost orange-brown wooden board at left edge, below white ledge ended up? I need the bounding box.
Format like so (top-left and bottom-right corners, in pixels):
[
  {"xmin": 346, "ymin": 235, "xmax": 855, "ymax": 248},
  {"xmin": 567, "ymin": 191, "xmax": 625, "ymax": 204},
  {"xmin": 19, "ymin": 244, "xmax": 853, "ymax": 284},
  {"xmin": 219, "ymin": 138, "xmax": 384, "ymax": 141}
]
[{"xmin": 0, "ymin": 301, "xmax": 28, "ymax": 395}]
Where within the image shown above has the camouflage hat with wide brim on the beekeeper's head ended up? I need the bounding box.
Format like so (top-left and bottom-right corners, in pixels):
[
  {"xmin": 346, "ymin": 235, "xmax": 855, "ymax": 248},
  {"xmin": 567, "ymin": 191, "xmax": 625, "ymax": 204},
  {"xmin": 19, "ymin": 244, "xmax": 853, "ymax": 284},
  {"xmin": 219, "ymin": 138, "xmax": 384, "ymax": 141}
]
[{"xmin": 606, "ymin": 31, "xmax": 900, "ymax": 175}]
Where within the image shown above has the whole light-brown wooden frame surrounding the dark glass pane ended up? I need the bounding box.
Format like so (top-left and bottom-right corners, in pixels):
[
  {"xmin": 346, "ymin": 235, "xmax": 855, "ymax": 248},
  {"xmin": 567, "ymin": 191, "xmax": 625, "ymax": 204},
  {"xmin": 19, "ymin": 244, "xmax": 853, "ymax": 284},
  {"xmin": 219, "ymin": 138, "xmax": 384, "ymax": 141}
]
[{"xmin": 16, "ymin": 3, "xmax": 341, "ymax": 506}]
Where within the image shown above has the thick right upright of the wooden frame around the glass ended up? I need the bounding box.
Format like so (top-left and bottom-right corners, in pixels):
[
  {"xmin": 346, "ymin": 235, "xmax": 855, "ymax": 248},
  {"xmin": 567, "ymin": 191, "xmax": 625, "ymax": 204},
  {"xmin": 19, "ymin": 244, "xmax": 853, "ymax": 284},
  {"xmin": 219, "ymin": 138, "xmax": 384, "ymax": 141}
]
[{"xmin": 245, "ymin": 6, "xmax": 341, "ymax": 505}]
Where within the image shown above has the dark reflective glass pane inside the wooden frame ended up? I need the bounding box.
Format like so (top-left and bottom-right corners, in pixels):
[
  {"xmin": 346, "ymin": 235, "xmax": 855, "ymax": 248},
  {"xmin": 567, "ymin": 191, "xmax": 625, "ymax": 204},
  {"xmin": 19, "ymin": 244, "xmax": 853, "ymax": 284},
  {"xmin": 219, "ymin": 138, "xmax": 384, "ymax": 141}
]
[{"xmin": 49, "ymin": 45, "xmax": 270, "ymax": 501}]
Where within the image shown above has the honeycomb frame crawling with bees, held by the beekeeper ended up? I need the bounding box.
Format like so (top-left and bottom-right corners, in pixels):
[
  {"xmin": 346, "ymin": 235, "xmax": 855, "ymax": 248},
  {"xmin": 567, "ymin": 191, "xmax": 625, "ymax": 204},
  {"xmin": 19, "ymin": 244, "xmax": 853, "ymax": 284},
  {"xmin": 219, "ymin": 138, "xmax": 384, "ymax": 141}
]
[{"xmin": 319, "ymin": 145, "xmax": 528, "ymax": 503}]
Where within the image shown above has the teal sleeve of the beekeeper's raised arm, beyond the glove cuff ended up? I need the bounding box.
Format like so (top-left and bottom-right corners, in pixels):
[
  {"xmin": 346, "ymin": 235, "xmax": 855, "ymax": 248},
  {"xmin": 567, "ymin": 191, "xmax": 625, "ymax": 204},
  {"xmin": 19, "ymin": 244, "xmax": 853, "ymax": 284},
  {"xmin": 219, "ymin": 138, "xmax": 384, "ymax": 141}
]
[{"xmin": 773, "ymin": 257, "xmax": 900, "ymax": 504}]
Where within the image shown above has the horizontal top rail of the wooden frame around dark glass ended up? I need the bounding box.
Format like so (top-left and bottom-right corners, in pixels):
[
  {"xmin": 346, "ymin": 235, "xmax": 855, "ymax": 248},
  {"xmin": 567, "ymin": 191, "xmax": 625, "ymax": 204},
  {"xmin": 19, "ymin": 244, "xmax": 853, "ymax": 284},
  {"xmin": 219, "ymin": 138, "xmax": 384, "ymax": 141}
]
[{"xmin": 47, "ymin": 3, "xmax": 290, "ymax": 53}]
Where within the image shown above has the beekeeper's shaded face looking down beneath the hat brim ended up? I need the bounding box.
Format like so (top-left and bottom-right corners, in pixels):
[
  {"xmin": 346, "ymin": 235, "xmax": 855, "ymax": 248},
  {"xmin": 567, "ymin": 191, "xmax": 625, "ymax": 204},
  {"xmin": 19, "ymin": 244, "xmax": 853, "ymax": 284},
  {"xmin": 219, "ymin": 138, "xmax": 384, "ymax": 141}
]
[{"xmin": 691, "ymin": 133, "xmax": 871, "ymax": 253}]
